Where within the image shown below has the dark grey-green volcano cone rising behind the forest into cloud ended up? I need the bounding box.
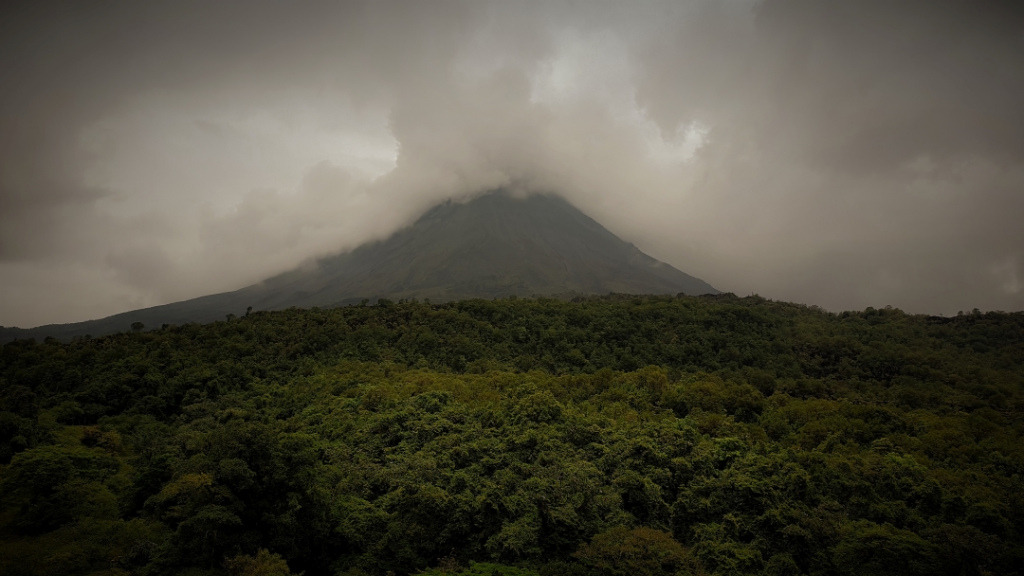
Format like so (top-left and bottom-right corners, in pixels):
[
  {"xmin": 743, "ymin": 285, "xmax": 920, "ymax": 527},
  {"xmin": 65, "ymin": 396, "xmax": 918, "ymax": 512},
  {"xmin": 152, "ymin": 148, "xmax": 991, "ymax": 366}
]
[{"xmin": 2, "ymin": 192, "xmax": 718, "ymax": 340}]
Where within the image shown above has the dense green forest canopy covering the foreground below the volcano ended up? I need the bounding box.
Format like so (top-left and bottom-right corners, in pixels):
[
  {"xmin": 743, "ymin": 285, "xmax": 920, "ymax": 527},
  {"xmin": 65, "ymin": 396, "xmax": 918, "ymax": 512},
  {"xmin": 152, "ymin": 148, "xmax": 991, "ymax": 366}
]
[{"xmin": 0, "ymin": 295, "xmax": 1024, "ymax": 576}]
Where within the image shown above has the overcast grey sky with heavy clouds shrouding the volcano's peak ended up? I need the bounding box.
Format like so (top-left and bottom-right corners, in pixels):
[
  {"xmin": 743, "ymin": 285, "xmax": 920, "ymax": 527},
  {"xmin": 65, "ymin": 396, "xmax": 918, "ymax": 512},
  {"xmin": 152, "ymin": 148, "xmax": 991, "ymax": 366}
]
[{"xmin": 0, "ymin": 0, "xmax": 1024, "ymax": 327}]
